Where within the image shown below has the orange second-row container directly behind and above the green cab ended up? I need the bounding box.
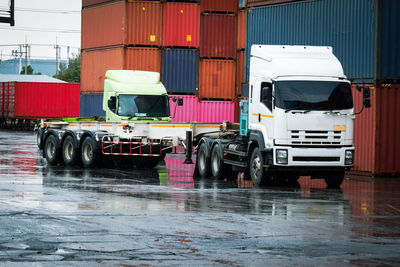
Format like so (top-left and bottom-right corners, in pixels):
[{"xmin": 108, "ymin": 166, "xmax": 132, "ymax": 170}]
[{"xmin": 81, "ymin": 47, "xmax": 161, "ymax": 94}]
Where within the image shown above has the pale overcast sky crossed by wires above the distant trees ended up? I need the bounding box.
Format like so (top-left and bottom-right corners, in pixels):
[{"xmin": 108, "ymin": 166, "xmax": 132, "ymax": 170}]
[{"xmin": 0, "ymin": 0, "xmax": 82, "ymax": 60}]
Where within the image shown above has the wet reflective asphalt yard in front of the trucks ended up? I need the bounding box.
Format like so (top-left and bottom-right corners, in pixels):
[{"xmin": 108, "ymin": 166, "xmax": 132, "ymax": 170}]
[{"xmin": 0, "ymin": 131, "xmax": 400, "ymax": 266}]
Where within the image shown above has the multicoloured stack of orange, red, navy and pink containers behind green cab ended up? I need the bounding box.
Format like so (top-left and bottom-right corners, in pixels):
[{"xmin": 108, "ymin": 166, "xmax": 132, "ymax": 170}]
[{"xmin": 81, "ymin": 0, "xmax": 238, "ymax": 122}]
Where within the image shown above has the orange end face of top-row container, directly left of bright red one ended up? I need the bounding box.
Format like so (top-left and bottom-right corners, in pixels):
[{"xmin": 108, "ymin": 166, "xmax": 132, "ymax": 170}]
[{"xmin": 125, "ymin": 1, "xmax": 163, "ymax": 46}]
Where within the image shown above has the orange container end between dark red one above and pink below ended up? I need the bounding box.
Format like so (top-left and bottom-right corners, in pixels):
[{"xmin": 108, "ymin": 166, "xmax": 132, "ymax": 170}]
[{"xmin": 199, "ymin": 59, "xmax": 236, "ymax": 99}]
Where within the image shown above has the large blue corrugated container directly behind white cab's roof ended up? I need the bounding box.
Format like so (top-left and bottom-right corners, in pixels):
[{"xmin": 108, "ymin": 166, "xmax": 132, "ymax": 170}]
[{"xmin": 246, "ymin": 0, "xmax": 376, "ymax": 82}]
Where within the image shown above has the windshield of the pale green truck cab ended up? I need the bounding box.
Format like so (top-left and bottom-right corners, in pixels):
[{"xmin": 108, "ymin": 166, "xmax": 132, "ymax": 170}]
[{"xmin": 118, "ymin": 95, "xmax": 169, "ymax": 117}]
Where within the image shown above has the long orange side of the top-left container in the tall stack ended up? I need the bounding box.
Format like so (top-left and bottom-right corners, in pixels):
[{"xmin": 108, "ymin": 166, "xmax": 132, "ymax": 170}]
[{"xmin": 81, "ymin": 1, "xmax": 125, "ymax": 50}]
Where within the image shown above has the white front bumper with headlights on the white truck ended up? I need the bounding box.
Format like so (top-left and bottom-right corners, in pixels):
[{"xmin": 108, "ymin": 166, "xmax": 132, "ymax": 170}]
[{"xmin": 273, "ymin": 146, "xmax": 354, "ymax": 167}]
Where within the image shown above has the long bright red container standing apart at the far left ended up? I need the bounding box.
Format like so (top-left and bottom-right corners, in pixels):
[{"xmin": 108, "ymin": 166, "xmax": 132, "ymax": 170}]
[{"xmin": 0, "ymin": 82, "xmax": 79, "ymax": 119}]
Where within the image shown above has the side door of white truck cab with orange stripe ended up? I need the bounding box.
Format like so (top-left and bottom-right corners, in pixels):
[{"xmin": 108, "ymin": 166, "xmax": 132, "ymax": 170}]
[{"xmin": 249, "ymin": 80, "xmax": 274, "ymax": 142}]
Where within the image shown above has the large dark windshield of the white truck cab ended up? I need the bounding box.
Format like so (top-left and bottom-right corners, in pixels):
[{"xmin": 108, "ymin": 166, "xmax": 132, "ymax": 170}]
[{"xmin": 275, "ymin": 81, "xmax": 353, "ymax": 110}]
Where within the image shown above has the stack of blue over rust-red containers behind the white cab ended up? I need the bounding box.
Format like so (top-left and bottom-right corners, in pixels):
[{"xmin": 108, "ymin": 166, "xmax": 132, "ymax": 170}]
[{"xmin": 245, "ymin": 0, "xmax": 400, "ymax": 174}]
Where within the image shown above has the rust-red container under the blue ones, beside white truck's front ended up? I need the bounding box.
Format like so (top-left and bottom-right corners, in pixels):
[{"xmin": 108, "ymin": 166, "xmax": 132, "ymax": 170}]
[{"xmin": 353, "ymin": 84, "xmax": 400, "ymax": 175}]
